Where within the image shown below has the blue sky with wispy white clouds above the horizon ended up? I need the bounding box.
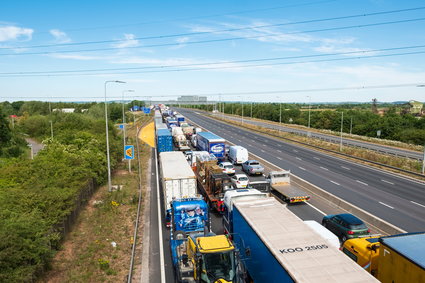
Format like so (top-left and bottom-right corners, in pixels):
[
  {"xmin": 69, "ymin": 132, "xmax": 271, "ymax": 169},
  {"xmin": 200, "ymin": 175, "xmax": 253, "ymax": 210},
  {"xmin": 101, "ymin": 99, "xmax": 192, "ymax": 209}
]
[{"xmin": 0, "ymin": 0, "xmax": 425, "ymax": 102}]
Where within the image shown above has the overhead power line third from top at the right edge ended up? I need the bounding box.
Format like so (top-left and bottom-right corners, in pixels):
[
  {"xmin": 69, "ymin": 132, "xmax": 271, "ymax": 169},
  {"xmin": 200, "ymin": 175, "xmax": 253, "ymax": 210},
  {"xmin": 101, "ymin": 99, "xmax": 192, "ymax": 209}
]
[{"xmin": 0, "ymin": 45, "xmax": 425, "ymax": 76}]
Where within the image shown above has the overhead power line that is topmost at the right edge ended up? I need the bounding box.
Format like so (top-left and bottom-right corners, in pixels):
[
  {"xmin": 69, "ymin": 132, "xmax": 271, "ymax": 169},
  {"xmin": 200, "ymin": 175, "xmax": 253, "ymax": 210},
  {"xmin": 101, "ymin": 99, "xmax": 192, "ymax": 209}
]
[{"xmin": 6, "ymin": 7, "xmax": 425, "ymax": 50}]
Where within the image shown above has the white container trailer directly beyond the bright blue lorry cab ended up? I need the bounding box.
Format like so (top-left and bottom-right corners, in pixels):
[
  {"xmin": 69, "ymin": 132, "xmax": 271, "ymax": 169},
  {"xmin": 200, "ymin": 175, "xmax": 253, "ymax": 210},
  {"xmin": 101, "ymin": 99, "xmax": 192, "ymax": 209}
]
[{"xmin": 159, "ymin": 151, "xmax": 198, "ymax": 227}]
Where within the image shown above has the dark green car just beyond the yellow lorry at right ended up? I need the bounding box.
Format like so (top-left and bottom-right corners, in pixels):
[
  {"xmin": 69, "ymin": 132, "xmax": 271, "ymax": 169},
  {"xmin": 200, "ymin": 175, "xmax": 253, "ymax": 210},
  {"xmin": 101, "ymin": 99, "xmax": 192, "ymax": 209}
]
[{"xmin": 322, "ymin": 213, "xmax": 370, "ymax": 243}]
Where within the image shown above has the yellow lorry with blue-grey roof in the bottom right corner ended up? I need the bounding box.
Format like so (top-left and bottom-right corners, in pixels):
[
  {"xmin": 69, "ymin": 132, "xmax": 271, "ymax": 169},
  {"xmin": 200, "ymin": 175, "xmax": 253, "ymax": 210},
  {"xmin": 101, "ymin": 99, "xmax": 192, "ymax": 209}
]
[{"xmin": 342, "ymin": 232, "xmax": 425, "ymax": 283}]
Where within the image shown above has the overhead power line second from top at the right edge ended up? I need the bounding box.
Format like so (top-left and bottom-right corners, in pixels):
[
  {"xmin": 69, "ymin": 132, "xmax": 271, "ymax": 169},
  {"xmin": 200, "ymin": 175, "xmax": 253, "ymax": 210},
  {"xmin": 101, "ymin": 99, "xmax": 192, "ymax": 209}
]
[{"xmin": 0, "ymin": 18, "xmax": 425, "ymax": 56}]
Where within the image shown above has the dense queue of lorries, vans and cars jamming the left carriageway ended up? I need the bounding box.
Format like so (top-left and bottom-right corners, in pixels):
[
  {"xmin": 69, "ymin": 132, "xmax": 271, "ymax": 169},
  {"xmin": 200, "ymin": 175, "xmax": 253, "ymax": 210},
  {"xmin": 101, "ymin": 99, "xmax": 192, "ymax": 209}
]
[{"xmin": 154, "ymin": 105, "xmax": 425, "ymax": 283}]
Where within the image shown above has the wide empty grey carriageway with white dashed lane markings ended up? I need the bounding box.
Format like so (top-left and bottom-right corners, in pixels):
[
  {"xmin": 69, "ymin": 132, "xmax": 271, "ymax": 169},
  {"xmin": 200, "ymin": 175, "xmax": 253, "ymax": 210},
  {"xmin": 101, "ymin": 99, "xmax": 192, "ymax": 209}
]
[{"xmin": 178, "ymin": 109, "xmax": 425, "ymax": 232}]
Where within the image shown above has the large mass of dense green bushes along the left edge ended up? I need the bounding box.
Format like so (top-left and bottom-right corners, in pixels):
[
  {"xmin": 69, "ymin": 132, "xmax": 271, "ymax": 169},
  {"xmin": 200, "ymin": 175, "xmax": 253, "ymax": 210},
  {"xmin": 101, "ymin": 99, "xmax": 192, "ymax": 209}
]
[{"xmin": 0, "ymin": 113, "xmax": 122, "ymax": 282}]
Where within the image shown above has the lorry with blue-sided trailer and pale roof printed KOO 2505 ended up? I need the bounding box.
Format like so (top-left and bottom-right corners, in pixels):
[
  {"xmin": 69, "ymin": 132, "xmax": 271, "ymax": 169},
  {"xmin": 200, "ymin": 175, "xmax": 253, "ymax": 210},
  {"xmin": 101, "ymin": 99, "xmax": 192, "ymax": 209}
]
[{"xmin": 226, "ymin": 197, "xmax": 378, "ymax": 283}]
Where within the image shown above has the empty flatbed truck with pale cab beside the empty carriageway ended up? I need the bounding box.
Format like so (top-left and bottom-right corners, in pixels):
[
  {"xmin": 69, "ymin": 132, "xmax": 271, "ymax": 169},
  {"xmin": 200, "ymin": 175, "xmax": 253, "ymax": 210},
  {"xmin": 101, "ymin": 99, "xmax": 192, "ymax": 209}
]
[{"xmin": 266, "ymin": 170, "xmax": 310, "ymax": 203}]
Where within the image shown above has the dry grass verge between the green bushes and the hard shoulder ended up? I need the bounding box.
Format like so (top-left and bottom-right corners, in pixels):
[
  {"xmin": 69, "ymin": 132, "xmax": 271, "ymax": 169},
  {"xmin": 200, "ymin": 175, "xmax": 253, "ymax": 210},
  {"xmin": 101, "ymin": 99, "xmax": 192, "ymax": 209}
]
[{"xmin": 40, "ymin": 117, "xmax": 151, "ymax": 282}]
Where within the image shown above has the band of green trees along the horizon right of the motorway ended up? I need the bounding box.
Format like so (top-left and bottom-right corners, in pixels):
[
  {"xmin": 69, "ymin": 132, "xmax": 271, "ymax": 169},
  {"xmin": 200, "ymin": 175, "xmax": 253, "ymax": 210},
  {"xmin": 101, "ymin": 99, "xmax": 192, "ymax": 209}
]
[{"xmin": 181, "ymin": 103, "xmax": 425, "ymax": 145}]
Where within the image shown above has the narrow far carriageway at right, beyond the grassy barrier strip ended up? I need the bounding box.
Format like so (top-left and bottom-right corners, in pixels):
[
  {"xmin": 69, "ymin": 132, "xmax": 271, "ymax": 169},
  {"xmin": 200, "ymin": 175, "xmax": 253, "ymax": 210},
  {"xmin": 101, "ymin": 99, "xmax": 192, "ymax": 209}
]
[{"xmin": 210, "ymin": 112, "xmax": 423, "ymax": 160}]
